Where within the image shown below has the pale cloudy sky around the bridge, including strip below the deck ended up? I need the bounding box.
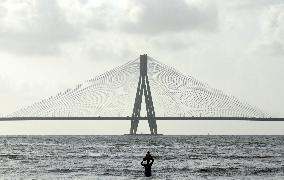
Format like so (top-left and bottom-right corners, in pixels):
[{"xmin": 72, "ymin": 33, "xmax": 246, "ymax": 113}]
[{"xmin": 0, "ymin": 0, "xmax": 284, "ymax": 134}]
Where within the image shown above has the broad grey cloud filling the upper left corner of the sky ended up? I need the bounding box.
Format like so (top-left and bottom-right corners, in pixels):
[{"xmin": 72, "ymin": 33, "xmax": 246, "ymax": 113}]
[{"xmin": 0, "ymin": 0, "xmax": 79, "ymax": 55}]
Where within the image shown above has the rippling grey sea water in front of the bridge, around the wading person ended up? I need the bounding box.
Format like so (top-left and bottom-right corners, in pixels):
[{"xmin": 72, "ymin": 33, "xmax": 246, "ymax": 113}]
[{"xmin": 0, "ymin": 135, "xmax": 284, "ymax": 179}]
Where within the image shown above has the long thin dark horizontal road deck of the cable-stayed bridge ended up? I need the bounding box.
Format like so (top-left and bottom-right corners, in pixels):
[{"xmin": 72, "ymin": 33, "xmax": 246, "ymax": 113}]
[{"xmin": 0, "ymin": 116, "xmax": 284, "ymax": 121}]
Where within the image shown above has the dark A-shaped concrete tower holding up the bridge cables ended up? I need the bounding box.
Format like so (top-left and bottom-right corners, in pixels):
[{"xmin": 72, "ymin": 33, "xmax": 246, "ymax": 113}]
[{"xmin": 130, "ymin": 54, "xmax": 157, "ymax": 135}]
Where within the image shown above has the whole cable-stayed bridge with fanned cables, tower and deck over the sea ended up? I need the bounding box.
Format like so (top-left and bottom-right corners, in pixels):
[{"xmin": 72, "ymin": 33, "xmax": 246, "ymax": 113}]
[{"xmin": 0, "ymin": 55, "xmax": 283, "ymax": 134}]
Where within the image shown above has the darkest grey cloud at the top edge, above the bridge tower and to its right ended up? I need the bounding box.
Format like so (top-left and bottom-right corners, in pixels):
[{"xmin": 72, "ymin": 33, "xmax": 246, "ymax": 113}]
[{"xmin": 121, "ymin": 0, "xmax": 218, "ymax": 35}]
